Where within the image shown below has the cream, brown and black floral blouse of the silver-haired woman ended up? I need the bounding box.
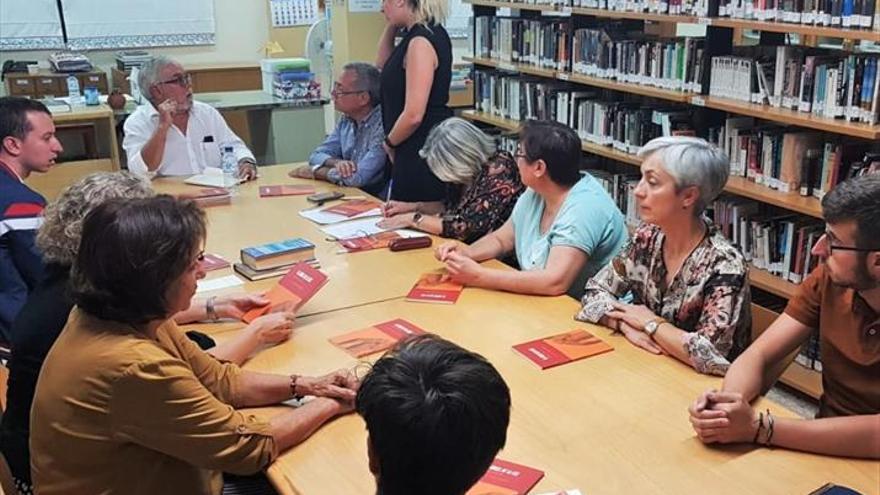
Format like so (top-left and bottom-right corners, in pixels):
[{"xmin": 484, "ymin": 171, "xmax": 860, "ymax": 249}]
[{"xmin": 575, "ymin": 221, "xmax": 751, "ymax": 375}]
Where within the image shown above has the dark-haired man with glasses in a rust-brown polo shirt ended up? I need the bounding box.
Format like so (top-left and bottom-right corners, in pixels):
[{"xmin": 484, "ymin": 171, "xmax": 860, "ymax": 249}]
[{"xmin": 690, "ymin": 174, "xmax": 880, "ymax": 459}]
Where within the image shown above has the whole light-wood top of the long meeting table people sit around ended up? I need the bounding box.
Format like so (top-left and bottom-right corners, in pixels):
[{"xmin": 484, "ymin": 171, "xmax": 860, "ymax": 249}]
[{"xmin": 157, "ymin": 166, "xmax": 880, "ymax": 495}]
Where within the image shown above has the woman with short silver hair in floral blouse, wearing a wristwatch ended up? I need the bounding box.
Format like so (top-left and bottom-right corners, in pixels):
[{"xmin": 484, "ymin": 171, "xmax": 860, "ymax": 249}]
[{"xmin": 576, "ymin": 136, "xmax": 751, "ymax": 375}]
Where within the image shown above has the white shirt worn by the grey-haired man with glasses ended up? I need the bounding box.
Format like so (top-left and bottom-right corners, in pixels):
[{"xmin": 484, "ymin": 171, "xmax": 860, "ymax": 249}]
[{"xmin": 122, "ymin": 101, "xmax": 256, "ymax": 175}]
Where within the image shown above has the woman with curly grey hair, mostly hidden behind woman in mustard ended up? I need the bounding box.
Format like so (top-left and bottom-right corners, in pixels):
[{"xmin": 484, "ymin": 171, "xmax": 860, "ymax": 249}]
[{"xmin": 0, "ymin": 172, "xmax": 294, "ymax": 493}]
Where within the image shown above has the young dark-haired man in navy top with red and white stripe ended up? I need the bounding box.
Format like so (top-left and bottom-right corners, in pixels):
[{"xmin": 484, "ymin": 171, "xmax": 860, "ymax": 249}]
[{"xmin": 0, "ymin": 97, "xmax": 62, "ymax": 342}]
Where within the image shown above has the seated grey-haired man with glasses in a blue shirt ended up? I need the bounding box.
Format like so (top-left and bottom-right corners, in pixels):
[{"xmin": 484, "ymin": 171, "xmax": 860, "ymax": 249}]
[{"xmin": 290, "ymin": 62, "xmax": 385, "ymax": 195}]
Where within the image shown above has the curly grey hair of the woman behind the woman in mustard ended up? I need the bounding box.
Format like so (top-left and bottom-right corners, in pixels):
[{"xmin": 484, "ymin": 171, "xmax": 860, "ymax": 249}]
[{"xmin": 37, "ymin": 172, "xmax": 156, "ymax": 265}]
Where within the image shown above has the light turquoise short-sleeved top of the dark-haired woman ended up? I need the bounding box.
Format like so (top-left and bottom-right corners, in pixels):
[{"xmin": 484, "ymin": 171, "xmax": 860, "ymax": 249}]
[{"xmin": 511, "ymin": 175, "xmax": 628, "ymax": 289}]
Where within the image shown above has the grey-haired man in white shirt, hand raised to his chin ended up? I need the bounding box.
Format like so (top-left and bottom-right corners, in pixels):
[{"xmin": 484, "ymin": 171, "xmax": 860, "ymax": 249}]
[{"xmin": 122, "ymin": 56, "xmax": 257, "ymax": 180}]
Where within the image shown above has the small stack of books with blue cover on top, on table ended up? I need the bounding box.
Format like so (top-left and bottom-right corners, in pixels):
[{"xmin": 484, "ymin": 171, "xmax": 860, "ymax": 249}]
[{"xmin": 233, "ymin": 238, "xmax": 318, "ymax": 280}]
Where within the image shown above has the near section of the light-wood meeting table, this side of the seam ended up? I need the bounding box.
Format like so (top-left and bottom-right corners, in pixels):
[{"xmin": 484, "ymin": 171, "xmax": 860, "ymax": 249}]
[{"xmin": 218, "ymin": 289, "xmax": 880, "ymax": 495}]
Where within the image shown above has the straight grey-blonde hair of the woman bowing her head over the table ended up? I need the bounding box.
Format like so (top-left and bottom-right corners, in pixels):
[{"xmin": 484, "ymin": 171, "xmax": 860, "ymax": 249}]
[{"xmin": 419, "ymin": 117, "xmax": 495, "ymax": 184}]
